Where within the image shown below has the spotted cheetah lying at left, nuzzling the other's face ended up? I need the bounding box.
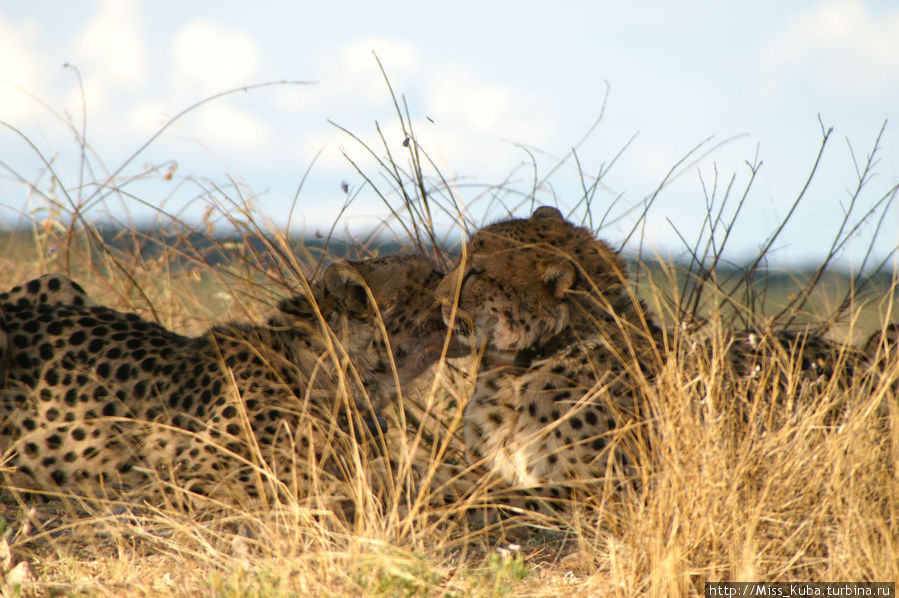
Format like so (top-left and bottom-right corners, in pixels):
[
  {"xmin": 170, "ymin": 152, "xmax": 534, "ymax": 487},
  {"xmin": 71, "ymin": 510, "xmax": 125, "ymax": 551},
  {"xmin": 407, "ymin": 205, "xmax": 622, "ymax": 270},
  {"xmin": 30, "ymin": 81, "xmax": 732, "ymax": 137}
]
[{"xmin": 0, "ymin": 256, "xmax": 446, "ymax": 500}]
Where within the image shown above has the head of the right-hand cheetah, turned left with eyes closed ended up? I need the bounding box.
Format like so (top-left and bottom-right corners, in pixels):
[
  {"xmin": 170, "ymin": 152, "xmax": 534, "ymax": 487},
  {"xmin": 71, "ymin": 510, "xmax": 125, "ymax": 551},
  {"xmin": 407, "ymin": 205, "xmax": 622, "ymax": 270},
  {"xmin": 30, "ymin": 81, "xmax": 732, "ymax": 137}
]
[{"xmin": 437, "ymin": 206, "xmax": 630, "ymax": 363}]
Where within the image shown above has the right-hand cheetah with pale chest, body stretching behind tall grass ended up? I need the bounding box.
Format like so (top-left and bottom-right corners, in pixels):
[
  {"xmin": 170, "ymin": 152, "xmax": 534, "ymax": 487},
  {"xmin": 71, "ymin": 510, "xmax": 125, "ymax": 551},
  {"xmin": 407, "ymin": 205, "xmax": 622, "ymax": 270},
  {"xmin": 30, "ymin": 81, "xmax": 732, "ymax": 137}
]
[{"xmin": 437, "ymin": 206, "xmax": 892, "ymax": 506}]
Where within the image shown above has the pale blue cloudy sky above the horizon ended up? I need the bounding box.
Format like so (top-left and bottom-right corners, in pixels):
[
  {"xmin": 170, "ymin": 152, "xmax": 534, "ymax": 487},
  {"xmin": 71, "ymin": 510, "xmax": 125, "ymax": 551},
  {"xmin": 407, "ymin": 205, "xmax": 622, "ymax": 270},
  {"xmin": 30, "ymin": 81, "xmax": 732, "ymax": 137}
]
[{"xmin": 0, "ymin": 0, "xmax": 899, "ymax": 263}]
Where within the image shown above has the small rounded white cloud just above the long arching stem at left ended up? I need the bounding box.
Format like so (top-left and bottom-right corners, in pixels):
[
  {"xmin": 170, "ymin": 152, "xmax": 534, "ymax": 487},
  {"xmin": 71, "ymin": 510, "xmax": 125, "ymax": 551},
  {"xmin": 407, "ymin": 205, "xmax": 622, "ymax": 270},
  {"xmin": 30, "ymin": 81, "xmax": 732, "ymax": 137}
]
[{"xmin": 172, "ymin": 20, "xmax": 260, "ymax": 97}]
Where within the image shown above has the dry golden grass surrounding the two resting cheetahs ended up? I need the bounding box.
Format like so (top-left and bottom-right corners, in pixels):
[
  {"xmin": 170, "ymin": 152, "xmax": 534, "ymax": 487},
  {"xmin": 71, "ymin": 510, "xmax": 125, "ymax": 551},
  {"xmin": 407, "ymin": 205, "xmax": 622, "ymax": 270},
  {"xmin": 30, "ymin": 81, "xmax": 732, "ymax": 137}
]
[{"xmin": 0, "ymin": 77, "xmax": 899, "ymax": 596}]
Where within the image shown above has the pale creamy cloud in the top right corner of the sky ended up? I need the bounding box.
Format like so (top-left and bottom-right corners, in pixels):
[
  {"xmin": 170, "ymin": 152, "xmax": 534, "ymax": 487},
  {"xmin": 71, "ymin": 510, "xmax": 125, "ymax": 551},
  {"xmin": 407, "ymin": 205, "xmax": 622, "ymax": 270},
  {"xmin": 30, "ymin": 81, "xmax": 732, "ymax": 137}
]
[{"xmin": 764, "ymin": 0, "xmax": 899, "ymax": 103}]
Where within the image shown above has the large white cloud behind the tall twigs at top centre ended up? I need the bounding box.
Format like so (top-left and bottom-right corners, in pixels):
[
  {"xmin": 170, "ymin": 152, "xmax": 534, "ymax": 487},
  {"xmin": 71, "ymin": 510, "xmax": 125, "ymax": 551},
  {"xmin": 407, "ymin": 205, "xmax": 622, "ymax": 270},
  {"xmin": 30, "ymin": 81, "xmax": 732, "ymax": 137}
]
[{"xmin": 279, "ymin": 37, "xmax": 553, "ymax": 180}]
